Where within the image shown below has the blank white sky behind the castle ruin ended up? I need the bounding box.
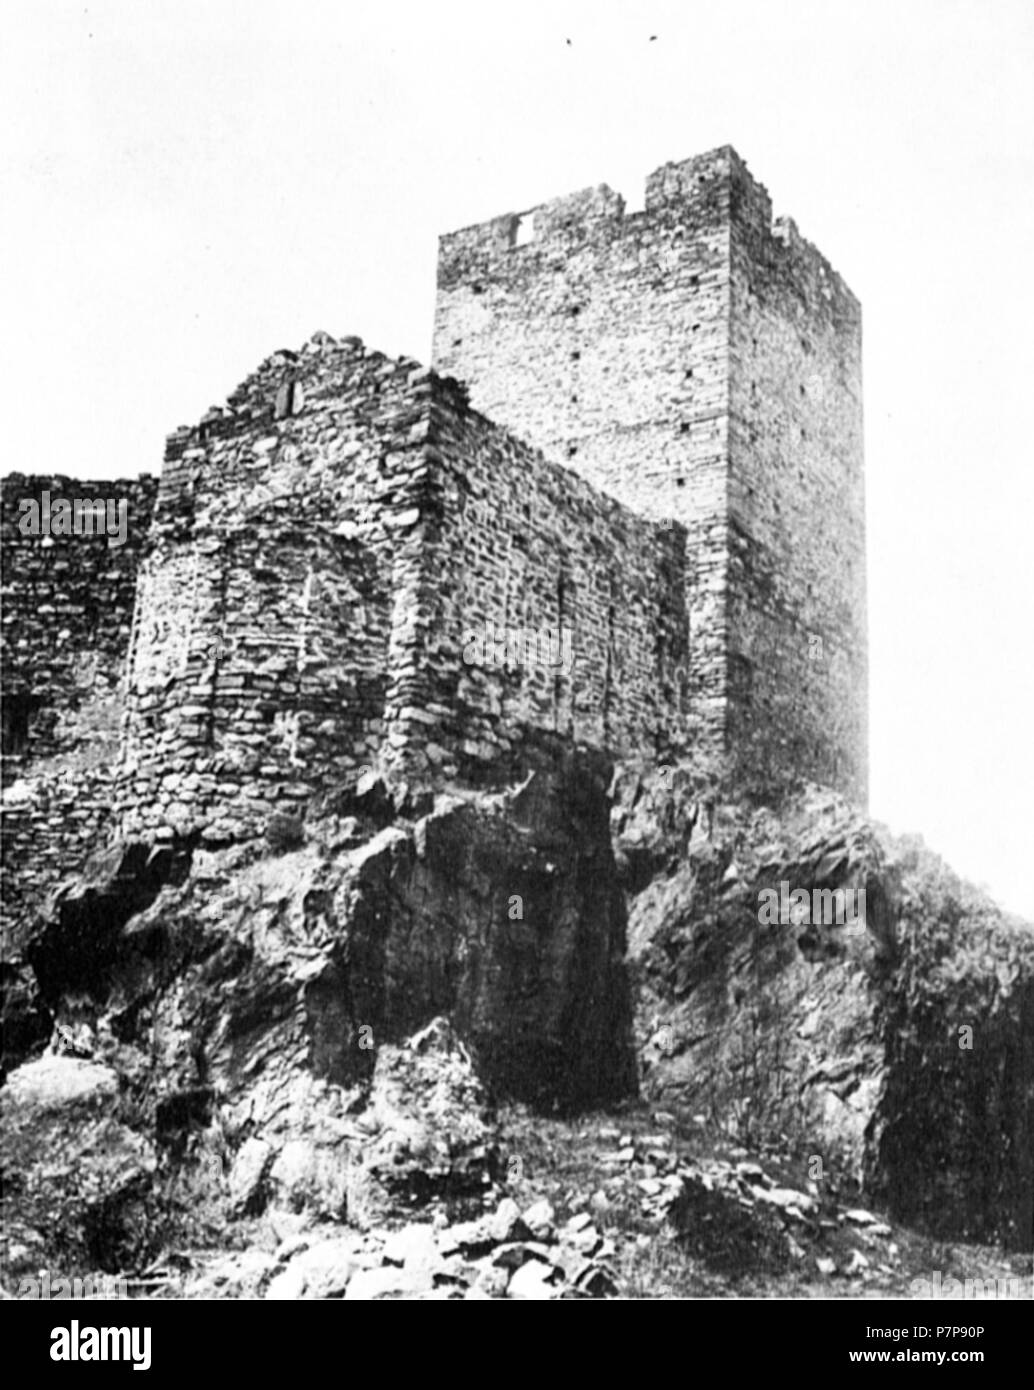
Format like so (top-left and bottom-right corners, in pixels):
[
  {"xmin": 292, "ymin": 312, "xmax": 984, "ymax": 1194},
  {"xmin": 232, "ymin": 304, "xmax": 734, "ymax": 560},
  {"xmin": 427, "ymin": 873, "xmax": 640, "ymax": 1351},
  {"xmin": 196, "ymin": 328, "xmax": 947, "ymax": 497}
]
[{"xmin": 0, "ymin": 0, "xmax": 1034, "ymax": 919}]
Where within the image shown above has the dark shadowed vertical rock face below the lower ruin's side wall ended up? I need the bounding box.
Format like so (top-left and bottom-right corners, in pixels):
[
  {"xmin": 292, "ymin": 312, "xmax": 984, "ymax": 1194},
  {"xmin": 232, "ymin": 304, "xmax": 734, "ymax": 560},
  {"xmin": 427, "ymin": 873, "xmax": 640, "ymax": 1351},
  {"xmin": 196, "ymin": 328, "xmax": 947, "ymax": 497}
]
[{"xmin": 341, "ymin": 756, "xmax": 635, "ymax": 1106}]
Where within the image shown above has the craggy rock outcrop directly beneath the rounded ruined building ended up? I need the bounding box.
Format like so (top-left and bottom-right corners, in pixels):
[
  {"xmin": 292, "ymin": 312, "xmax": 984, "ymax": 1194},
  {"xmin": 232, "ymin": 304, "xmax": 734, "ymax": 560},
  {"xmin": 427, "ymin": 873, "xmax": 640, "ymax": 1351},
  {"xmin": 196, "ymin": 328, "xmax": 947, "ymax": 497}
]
[{"xmin": 13, "ymin": 755, "xmax": 635, "ymax": 1267}]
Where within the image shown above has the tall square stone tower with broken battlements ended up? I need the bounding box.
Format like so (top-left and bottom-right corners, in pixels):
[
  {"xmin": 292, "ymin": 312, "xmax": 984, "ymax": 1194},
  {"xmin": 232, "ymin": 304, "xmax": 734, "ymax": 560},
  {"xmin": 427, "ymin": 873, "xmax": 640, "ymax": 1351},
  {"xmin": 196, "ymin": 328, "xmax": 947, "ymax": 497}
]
[{"xmin": 434, "ymin": 146, "xmax": 867, "ymax": 803}]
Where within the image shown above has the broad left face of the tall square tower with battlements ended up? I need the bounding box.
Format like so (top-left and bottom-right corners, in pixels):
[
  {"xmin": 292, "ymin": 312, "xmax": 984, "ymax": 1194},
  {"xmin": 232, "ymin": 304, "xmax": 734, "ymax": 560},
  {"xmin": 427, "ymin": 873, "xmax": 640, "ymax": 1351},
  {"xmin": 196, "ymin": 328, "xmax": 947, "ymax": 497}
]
[{"xmin": 432, "ymin": 157, "xmax": 730, "ymax": 761}]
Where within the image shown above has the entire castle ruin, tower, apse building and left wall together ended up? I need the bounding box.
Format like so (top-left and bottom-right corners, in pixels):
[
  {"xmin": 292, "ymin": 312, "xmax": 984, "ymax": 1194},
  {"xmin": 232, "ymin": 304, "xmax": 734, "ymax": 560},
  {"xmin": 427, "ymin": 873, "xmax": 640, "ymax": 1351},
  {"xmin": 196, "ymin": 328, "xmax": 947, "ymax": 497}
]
[{"xmin": 4, "ymin": 147, "xmax": 866, "ymax": 910}]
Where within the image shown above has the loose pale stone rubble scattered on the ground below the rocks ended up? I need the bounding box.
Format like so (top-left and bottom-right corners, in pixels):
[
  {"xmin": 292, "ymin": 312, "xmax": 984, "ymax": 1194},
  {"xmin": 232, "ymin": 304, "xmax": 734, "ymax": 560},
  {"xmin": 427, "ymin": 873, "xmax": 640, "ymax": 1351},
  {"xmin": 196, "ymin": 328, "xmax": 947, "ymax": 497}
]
[{"xmin": 199, "ymin": 1133, "xmax": 896, "ymax": 1301}]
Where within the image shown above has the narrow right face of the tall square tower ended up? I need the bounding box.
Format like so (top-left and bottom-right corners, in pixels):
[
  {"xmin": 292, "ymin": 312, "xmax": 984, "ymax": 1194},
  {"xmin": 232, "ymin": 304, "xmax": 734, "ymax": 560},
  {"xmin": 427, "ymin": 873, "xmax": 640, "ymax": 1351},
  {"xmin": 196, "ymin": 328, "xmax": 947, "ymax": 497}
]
[{"xmin": 728, "ymin": 201, "xmax": 867, "ymax": 806}]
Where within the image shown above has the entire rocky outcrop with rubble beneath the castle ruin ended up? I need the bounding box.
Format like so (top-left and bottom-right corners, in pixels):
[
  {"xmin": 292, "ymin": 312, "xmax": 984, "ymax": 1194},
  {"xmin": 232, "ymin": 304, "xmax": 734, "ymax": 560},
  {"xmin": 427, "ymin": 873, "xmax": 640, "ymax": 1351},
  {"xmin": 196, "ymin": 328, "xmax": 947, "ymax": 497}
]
[{"xmin": 3, "ymin": 753, "xmax": 1034, "ymax": 1278}]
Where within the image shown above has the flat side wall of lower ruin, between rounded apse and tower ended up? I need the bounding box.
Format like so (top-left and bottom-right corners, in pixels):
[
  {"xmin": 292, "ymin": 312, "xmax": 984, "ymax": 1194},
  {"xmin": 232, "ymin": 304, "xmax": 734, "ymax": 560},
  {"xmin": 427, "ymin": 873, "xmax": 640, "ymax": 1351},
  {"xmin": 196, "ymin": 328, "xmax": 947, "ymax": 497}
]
[{"xmin": 409, "ymin": 382, "xmax": 688, "ymax": 777}]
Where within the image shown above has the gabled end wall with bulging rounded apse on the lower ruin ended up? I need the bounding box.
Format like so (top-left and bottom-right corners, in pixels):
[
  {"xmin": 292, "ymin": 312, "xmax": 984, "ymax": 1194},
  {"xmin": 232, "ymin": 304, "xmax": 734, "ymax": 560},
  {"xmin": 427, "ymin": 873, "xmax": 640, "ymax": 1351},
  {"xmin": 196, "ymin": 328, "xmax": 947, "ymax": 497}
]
[{"xmin": 120, "ymin": 334, "xmax": 425, "ymax": 840}]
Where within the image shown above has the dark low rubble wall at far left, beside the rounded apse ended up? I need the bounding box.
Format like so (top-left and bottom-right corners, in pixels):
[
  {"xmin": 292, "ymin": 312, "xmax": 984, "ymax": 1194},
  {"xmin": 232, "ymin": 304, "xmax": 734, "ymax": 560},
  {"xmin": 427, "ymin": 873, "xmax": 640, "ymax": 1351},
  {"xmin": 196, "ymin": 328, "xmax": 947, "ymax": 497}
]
[{"xmin": 0, "ymin": 473, "xmax": 157, "ymax": 955}]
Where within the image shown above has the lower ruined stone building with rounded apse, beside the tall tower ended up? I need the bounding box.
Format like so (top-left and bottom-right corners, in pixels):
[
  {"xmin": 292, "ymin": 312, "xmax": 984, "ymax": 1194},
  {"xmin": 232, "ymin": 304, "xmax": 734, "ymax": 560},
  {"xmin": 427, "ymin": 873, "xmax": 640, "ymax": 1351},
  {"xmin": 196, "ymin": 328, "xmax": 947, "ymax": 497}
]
[{"xmin": 118, "ymin": 335, "xmax": 688, "ymax": 841}]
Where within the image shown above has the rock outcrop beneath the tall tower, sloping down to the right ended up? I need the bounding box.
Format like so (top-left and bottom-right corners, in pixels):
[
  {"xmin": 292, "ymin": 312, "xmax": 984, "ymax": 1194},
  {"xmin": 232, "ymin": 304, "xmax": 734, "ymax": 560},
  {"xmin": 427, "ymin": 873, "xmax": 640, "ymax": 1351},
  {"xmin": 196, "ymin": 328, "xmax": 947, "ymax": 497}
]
[{"xmin": 614, "ymin": 774, "xmax": 1034, "ymax": 1248}]
